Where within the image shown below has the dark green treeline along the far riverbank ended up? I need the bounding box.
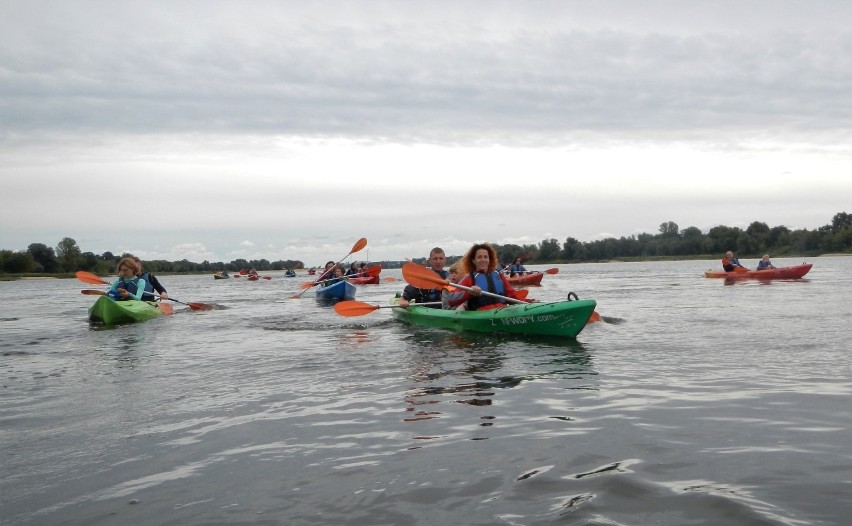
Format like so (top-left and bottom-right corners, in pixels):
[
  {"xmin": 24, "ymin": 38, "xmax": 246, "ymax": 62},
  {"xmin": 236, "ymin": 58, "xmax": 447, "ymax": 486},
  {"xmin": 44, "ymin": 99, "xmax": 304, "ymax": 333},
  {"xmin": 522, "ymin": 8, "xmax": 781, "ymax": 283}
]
[{"xmin": 0, "ymin": 212, "xmax": 852, "ymax": 275}]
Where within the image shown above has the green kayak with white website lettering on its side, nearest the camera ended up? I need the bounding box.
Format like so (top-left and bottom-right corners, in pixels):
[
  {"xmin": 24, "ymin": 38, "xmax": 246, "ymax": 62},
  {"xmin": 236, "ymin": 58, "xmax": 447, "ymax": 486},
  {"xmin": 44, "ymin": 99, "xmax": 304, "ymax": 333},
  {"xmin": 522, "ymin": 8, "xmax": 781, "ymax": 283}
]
[{"xmin": 391, "ymin": 299, "xmax": 597, "ymax": 338}]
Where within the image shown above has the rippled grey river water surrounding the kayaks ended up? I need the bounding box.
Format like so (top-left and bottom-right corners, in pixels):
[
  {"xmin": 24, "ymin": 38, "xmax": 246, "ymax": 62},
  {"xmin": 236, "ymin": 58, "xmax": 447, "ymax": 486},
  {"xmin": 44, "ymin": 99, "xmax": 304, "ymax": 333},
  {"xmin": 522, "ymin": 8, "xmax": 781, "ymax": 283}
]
[{"xmin": 0, "ymin": 257, "xmax": 852, "ymax": 526}]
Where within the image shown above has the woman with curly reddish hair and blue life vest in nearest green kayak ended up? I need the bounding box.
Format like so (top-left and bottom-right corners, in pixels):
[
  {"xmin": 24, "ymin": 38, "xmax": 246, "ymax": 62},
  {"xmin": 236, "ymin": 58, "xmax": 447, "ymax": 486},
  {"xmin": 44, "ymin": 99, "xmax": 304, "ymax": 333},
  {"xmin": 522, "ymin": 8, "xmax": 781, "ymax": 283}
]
[{"xmin": 449, "ymin": 243, "xmax": 529, "ymax": 310}]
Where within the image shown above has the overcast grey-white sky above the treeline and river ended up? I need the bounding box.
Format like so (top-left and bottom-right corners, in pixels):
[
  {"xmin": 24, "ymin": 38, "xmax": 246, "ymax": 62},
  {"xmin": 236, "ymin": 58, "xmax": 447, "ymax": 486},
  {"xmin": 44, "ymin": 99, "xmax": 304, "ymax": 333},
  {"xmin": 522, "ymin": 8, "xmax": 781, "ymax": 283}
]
[{"xmin": 0, "ymin": 0, "xmax": 852, "ymax": 264}]
